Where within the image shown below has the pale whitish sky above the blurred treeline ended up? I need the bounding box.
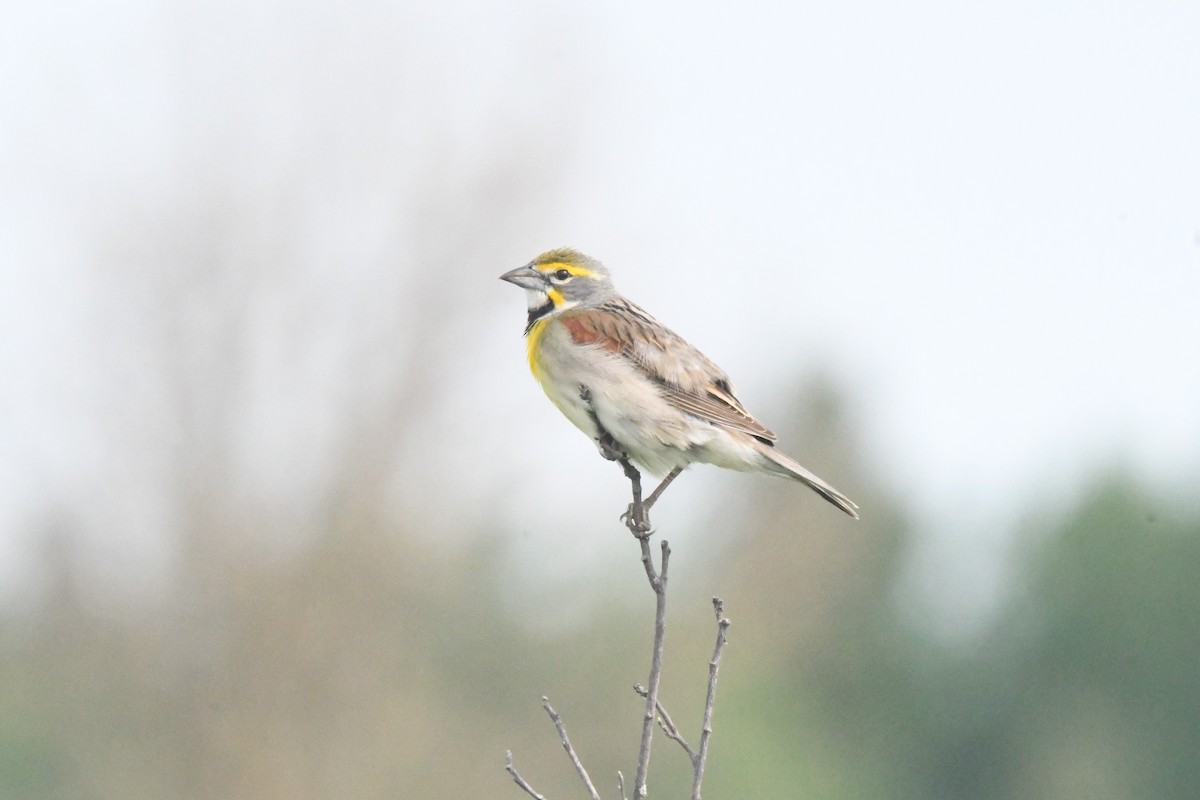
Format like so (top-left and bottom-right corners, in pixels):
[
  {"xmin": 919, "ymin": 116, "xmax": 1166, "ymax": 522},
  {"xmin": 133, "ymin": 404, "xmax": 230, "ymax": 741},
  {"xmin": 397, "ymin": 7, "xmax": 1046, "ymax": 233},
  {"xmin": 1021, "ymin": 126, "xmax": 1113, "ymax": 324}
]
[{"xmin": 0, "ymin": 0, "xmax": 1200, "ymax": 623}]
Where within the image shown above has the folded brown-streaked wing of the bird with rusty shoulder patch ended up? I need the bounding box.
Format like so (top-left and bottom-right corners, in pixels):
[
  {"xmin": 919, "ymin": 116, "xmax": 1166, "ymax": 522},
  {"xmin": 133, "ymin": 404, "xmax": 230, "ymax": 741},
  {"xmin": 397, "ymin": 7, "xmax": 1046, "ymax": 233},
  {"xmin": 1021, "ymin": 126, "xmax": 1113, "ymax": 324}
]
[{"xmin": 562, "ymin": 299, "xmax": 779, "ymax": 444}]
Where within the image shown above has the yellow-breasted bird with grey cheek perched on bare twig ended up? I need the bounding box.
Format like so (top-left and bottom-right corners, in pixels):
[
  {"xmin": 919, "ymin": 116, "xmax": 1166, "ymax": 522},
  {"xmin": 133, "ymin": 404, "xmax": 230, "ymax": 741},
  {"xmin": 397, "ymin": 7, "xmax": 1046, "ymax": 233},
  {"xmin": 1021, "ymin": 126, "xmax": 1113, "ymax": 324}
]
[{"xmin": 500, "ymin": 247, "xmax": 858, "ymax": 519}]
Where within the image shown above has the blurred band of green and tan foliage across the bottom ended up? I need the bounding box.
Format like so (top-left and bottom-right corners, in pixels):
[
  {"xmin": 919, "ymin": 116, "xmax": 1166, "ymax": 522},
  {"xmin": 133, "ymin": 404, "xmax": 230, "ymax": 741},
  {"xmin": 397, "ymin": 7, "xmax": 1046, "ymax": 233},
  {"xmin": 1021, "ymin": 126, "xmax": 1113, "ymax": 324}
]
[{"xmin": 0, "ymin": 448, "xmax": 1200, "ymax": 800}]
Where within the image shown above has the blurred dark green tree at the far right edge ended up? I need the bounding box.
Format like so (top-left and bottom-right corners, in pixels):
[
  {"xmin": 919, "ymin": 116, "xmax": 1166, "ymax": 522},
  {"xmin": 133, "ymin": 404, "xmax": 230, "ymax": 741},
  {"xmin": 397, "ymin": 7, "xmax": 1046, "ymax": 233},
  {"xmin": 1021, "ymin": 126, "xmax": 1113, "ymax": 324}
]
[{"xmin": 991, "ymin": 474, "xmax": 1200, "ymax": 799}]
